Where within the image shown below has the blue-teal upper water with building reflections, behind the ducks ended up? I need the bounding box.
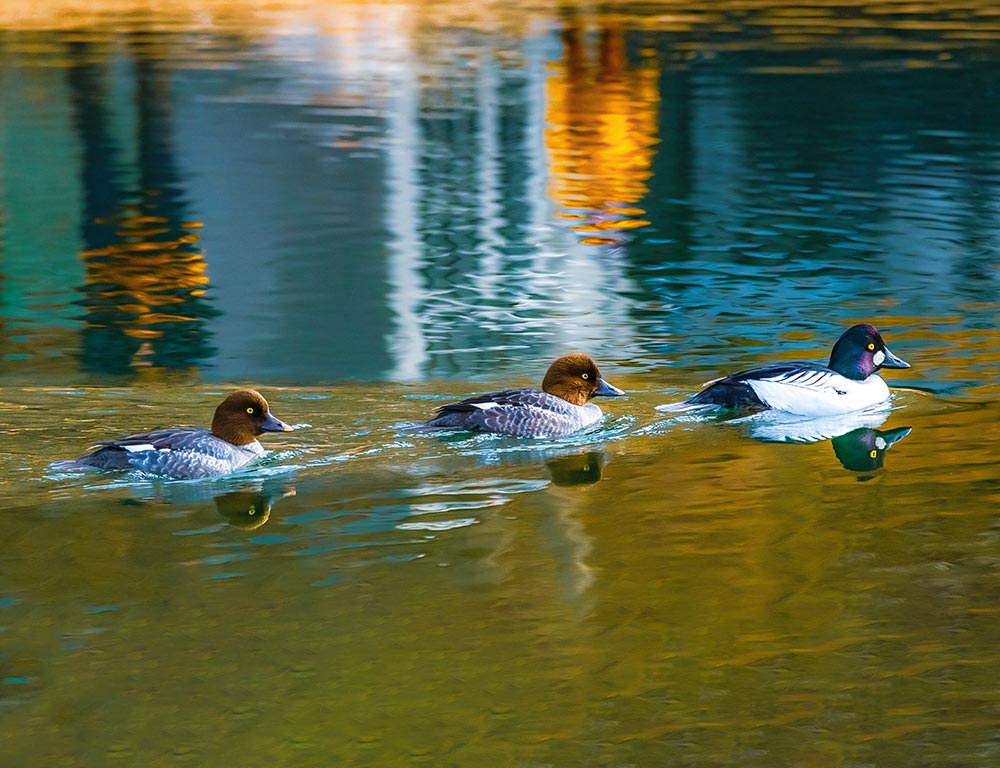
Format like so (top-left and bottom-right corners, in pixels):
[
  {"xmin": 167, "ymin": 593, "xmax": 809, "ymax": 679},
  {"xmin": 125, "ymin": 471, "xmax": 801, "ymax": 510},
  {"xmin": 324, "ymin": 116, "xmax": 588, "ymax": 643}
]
[{"xmin": 0, "ymin": 0, "xmax": 1000, "ymax": 383}]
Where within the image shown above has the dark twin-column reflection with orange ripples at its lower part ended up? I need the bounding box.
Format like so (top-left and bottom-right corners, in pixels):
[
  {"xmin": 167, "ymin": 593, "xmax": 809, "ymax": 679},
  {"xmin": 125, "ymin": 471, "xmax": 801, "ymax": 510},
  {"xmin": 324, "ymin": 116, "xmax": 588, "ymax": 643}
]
[{"xmin": 66, "ymin": 39, "xmax": 215, "ymax": 374}]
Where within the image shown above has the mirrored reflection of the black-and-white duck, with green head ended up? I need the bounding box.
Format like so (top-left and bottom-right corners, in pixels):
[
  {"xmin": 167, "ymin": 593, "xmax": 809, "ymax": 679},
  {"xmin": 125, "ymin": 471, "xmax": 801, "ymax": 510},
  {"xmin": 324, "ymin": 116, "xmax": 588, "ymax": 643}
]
[{"xmin": 737, "ymin": 408, "xmax": 912, "ymax": 480}]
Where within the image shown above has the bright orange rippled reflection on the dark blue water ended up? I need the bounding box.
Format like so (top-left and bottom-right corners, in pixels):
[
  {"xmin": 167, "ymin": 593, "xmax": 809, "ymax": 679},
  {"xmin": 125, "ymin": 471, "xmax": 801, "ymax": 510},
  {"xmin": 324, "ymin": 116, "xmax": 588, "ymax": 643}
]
[{"xmin": 545, "ymin": 22, "xmax": 660, "ymax": 244}]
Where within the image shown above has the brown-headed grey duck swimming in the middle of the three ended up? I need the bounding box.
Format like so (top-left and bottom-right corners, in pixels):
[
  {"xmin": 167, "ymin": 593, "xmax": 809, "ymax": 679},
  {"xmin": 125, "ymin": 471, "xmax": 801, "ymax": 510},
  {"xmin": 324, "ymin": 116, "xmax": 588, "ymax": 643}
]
[{"xmin": 424, "ymin": 354, "xmax": 625, "ymax": 437}]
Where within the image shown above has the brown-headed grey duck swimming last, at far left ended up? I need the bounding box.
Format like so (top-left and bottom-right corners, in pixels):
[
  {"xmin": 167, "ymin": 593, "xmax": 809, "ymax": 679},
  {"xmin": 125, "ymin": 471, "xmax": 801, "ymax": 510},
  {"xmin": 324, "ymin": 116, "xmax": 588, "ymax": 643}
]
[{"xmin": 52, "ymin": 389, "xmax": 292, "ymax": 478}]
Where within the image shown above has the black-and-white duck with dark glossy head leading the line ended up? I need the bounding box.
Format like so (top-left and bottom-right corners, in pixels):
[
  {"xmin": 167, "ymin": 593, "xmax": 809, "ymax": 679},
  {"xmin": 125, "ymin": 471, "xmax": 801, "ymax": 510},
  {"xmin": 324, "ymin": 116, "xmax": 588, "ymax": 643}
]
[{"xmin": 657, "ymin": 324, "xmax": 910, "ymax": 416}]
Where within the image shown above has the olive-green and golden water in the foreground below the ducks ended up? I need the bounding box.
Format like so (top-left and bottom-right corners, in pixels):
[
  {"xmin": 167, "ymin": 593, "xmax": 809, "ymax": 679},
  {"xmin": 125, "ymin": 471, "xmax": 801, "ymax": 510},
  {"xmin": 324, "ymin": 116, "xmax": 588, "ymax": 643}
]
[{"xmin": 0, "ymin": 377, "xmax": 1000, "ymax": 766}]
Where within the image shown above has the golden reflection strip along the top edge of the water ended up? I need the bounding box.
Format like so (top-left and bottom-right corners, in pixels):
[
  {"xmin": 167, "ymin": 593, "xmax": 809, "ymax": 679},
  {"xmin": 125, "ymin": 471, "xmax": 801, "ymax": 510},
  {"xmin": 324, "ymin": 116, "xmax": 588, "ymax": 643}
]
[{"xmin": 0, "ymin": 0, "xmax": 1000, "ymax": 49}]
